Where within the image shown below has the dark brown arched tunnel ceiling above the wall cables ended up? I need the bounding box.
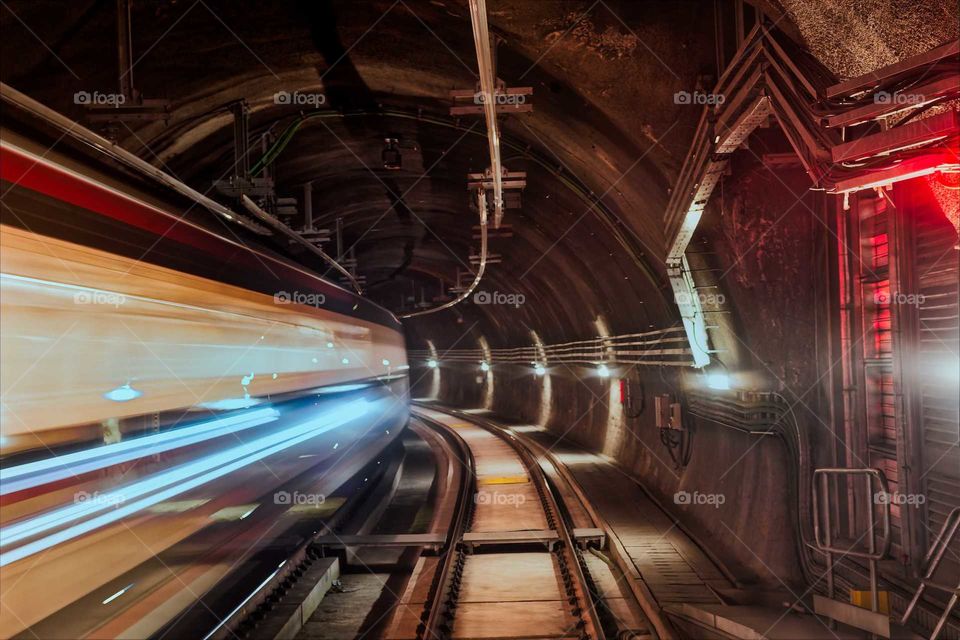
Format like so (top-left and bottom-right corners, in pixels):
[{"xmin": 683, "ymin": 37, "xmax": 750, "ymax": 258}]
[{"xmin": 0, "ymin": 0, "xmax": 952, "ymax": 344}]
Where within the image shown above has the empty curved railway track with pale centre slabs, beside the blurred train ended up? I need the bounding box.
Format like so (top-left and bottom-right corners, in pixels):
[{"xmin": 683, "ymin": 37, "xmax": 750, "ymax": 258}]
[{"xmin": 384, "ymin": 407, "xmax": 649, "ymax": 640}]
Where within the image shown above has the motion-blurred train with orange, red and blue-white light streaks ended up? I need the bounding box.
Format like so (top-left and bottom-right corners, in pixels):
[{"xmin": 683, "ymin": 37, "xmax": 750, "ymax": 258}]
[{"xmin": 0, "ymin": 87, "xmax": 409, "ymax": 637}]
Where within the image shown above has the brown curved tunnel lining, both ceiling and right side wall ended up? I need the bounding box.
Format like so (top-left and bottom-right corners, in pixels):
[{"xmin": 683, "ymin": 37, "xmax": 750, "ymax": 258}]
[{"xmin": 0, "ymin": 1, "xmax": 955, "ymax": 596}]
